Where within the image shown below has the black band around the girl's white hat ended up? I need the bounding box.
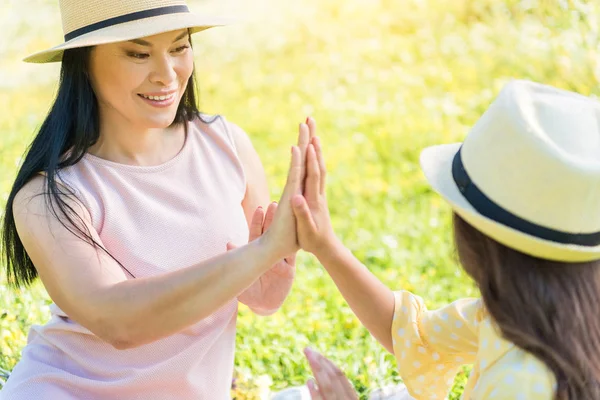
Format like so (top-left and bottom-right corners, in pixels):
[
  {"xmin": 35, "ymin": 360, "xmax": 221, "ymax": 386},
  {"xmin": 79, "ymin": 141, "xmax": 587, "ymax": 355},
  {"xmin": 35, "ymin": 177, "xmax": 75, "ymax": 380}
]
[{"xmin": 452, "ymin": 147, "xmax": 600, "ymax": 247}]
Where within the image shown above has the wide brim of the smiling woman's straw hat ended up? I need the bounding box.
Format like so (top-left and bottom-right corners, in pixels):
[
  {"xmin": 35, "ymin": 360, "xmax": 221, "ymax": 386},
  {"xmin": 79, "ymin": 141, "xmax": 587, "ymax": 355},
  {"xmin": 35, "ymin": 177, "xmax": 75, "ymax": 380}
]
[{"xmin": 23, "ymin": 13, "xmax": 234, "ymax": 63}]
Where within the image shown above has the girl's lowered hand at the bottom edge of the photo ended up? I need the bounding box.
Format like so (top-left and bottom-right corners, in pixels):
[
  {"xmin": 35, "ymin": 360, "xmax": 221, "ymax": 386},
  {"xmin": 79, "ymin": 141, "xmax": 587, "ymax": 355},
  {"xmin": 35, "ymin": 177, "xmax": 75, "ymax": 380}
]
[{"xmin": 304, "ymin": 348, "xmax": 358, "ymax": 400}]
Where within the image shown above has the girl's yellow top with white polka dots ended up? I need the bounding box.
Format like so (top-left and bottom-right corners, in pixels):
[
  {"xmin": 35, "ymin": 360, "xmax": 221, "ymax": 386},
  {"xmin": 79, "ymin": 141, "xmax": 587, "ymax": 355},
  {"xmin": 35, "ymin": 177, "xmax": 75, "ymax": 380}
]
[{"xmin": 392, "ymin": 291, "xmax": 556, "ymax": 400}]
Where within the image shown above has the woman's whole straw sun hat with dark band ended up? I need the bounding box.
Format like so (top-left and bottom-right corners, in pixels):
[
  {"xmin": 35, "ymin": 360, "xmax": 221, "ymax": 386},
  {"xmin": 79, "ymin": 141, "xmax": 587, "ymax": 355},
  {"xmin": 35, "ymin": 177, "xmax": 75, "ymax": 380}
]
[{"xmin": 24, "ymin": 0, "xmax": 230, "ymax": 63}]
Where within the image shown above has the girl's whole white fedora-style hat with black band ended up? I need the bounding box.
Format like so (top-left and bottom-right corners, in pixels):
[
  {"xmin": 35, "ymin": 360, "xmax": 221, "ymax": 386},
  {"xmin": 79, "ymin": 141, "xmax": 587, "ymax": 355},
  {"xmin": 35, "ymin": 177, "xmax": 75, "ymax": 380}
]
[{"xmin": 421, "ymin": 80, "xmax": 600, "ymax": 262}]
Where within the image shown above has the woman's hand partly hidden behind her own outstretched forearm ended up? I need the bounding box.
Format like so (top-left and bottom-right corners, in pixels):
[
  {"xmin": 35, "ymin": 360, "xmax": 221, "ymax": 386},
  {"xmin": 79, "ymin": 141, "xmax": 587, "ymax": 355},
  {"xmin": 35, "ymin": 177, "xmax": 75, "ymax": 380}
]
[{"xmin": 227, "ymin": 202, "xmax": 296, "ymax": 315}]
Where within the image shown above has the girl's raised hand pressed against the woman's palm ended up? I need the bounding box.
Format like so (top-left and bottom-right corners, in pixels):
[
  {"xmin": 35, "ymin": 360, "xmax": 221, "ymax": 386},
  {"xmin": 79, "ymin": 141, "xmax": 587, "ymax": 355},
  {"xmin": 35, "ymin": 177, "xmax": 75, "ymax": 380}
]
[{"xmin": 292, "ymin": 121, "xmax": 336, "ymax": 257}]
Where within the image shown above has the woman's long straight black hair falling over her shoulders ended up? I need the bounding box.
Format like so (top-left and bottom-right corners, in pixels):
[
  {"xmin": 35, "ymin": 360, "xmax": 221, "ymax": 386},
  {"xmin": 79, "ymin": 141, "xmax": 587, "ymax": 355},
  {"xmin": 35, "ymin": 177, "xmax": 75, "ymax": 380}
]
[{"xmin": 1, "ymin": 38, "xmax": 211, "ymax": 287}]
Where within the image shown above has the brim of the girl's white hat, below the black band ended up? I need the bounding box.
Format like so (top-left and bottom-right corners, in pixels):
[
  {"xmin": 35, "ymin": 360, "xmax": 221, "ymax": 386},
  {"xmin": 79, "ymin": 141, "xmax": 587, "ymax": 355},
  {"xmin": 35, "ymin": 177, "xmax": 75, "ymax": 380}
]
[{"xmin": 420, "ymin": 143, "xmax": 600, "ymax": 262}]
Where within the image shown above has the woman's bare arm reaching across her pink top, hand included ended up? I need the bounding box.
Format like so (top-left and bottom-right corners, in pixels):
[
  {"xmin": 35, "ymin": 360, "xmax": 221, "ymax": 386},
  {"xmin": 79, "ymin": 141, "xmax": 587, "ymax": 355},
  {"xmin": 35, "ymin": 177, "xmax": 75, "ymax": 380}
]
[{"xmin": 13, "ymin": 139, "xmax": 307, "ymax": 349}]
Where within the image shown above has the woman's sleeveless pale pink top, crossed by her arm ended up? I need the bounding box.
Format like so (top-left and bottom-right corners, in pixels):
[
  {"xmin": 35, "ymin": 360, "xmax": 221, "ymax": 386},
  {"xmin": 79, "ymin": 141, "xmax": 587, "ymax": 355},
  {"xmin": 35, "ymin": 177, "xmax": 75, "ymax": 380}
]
[{"xmin": 0, "ymin": 117, "xmax": 253, "ymax": 400}]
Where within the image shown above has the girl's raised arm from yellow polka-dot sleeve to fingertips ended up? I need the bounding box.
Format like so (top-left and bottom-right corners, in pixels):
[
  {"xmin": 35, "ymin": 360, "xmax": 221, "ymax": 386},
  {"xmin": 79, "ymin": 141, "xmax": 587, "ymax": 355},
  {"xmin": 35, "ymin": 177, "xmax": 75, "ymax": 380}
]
[{"xmin": 292, "ymin": 134, "xmax": 480, "ymax": 399}]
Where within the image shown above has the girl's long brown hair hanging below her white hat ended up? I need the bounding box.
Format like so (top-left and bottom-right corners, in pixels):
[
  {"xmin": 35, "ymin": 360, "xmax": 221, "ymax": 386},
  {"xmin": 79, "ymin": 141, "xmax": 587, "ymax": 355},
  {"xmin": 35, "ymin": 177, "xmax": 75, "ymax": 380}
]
[{"xmin": 453, "ymin": 213, "xmax": 600, "ymax": 400}]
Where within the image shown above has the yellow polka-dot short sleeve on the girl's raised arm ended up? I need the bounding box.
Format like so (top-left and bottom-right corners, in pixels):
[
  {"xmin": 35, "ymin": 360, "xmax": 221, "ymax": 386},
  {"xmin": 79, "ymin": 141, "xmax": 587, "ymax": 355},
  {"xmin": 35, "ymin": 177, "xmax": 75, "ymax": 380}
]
[{"xmin": 392, "ymin": 291, "xmax": 482, "ymax": 399}]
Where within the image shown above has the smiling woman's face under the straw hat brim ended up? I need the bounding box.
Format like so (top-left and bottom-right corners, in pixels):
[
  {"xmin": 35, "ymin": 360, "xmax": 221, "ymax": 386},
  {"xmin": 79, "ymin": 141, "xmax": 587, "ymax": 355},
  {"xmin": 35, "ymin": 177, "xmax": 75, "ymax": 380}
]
[{"xmin": 90, "ymin": 29, "xmax": 194, "ymax": 129}]
